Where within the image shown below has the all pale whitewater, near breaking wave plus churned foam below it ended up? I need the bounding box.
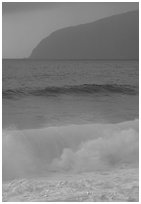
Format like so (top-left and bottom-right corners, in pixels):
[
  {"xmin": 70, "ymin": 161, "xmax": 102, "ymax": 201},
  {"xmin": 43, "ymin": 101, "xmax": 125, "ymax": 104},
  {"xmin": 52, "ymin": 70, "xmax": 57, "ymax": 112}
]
[{"xmin": 3, "ymin": 120, "xmax": 139, "ymax": 201}]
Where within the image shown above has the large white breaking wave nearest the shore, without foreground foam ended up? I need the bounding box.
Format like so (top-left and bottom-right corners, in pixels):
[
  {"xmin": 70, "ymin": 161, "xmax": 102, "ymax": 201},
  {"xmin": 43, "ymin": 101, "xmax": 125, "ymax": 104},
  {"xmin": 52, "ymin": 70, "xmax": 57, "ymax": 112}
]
[{"xmin": 3, "ymin": 120, "xmax": 139, "ymax": 180}]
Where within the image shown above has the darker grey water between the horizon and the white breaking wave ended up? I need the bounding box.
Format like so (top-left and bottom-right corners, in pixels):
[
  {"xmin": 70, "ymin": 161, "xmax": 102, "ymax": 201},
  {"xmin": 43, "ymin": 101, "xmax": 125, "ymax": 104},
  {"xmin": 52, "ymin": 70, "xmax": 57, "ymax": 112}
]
[{"xmin": 2, "ymin": 60, "xmax": 139, "ymax": 129}]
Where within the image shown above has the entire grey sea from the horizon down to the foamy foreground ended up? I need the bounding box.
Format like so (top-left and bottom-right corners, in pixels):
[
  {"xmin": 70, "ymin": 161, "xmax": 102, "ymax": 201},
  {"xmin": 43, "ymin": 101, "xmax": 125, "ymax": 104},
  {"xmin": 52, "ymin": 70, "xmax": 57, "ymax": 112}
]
[{"xmin": 2, "ymin": 59, "xmax": 139, "ymax": 201}]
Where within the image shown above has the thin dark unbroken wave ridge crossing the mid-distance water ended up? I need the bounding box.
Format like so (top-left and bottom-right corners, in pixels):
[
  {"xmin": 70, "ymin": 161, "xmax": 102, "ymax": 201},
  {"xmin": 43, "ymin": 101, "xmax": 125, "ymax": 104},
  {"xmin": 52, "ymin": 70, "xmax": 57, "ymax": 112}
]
[{"xmin": 2, "ymin": 84, "xmax": 138, "ymax": 99}]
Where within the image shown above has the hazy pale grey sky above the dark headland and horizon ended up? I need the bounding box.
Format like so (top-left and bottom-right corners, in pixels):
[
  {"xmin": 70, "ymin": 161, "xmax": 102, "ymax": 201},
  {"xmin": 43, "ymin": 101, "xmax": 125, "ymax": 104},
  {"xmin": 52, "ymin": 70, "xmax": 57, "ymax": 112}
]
[{"xmin": 2, "ymin": 2, "xmax": 138, "ymax": 58}]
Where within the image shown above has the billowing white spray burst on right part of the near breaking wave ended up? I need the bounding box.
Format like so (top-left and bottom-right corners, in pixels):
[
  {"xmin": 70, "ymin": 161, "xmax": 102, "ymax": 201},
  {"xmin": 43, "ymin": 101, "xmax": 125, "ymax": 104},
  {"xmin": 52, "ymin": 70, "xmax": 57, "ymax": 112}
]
[{"xmin": 53, "ymin": 129, "xmax": 139, "ymax": 172}]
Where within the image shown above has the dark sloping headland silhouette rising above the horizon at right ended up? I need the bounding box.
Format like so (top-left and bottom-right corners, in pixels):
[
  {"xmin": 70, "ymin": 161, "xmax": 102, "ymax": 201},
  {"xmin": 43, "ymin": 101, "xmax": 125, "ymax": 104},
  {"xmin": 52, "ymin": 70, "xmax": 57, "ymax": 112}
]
[{"xmin": 30, "ymin": 11, "xmax": 139, "ymax": 60}]
